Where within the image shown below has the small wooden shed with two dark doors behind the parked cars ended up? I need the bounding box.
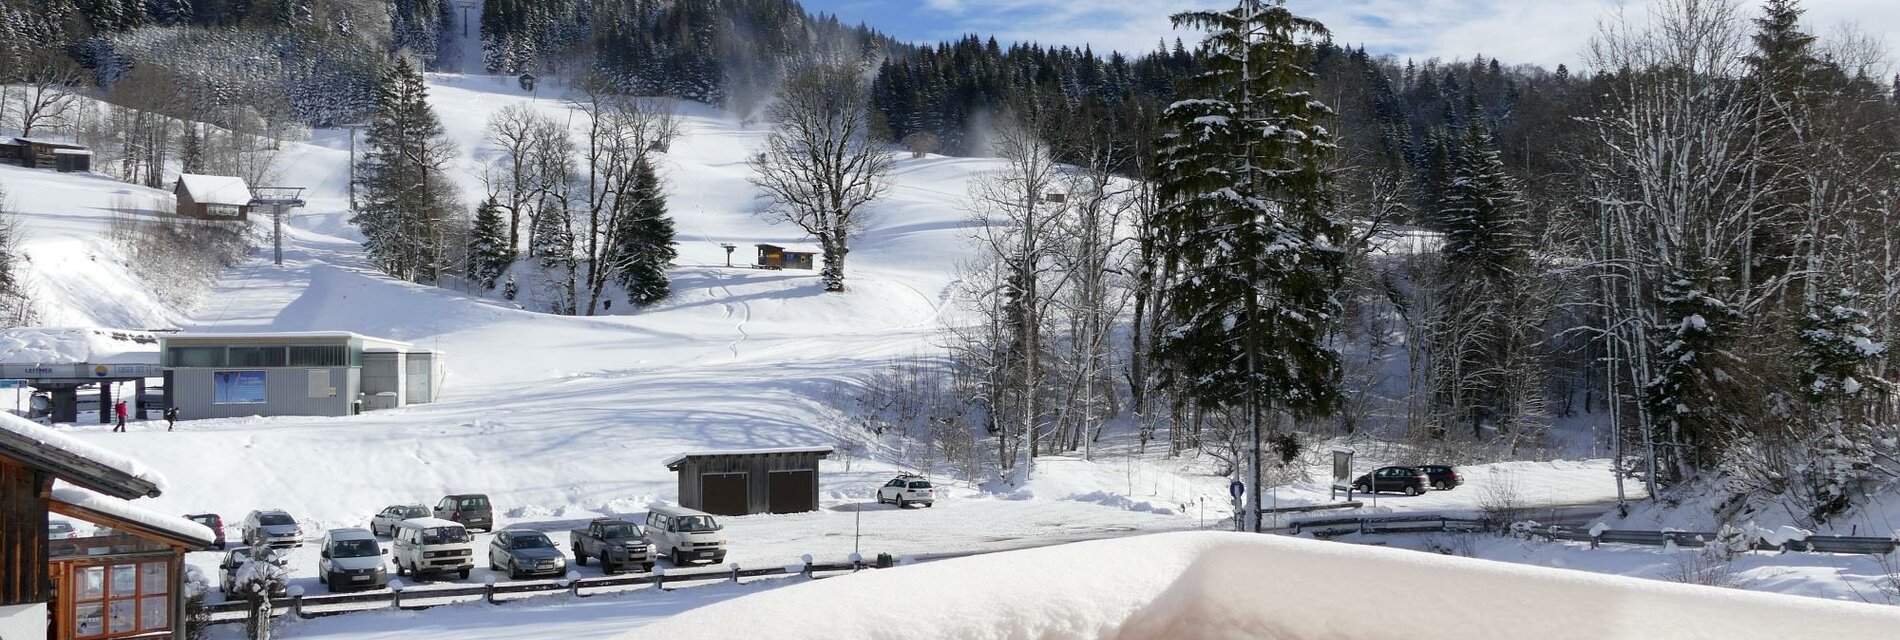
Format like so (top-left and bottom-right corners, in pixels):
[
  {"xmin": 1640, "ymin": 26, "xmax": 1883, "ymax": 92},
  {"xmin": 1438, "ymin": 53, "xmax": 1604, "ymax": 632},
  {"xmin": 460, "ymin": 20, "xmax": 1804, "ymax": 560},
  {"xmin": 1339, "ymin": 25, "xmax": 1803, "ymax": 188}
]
[{"xmin": 667, "ymin": 446, "xmax": 832, "ymax": 515}]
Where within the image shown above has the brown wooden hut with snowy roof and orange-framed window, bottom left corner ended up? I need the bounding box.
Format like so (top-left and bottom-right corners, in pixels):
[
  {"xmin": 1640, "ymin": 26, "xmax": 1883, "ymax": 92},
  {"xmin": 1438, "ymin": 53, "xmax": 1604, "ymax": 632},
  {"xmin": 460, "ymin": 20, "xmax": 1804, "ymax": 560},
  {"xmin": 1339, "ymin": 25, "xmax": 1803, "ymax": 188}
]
[{"xmin": 0, "ymin": 416, "xmax": 215, "ymax": 640}]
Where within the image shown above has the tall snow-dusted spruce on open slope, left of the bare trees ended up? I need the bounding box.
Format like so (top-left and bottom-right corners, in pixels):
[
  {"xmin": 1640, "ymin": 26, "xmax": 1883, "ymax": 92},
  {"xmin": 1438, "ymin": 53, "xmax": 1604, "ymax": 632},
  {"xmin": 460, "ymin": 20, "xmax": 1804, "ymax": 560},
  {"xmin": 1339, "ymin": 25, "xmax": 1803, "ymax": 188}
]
[{"xmin": 352, "ymin": 57, "xmax": 456, "ymax": 283}]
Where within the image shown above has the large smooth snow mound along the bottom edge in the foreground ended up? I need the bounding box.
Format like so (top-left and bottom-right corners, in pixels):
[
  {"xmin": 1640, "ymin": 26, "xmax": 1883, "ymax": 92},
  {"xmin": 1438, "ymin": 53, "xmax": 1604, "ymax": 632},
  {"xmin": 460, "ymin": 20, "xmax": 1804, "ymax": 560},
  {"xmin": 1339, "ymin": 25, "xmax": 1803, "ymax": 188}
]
[{"xmin": 623, "ymin": 534, "xmax": 1900, "ymax": 640}]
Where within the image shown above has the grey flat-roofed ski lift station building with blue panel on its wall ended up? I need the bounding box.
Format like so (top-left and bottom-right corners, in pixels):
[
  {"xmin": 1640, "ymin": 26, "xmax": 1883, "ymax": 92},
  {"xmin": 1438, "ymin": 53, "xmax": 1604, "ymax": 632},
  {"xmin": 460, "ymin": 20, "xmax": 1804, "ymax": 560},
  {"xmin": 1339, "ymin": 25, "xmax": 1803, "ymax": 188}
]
[{"xmin": 160, "ymin": 330, "xmax": 447, "ymax": 420}]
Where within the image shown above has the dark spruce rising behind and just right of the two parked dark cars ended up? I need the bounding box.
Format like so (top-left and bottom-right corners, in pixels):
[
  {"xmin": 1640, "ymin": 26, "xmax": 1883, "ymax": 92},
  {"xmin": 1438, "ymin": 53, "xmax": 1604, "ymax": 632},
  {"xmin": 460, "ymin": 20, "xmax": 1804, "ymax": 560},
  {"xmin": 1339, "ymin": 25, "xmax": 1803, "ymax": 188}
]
[{"xmin": 1433, "ymin": 114, "xmax": 1537, "ymax": 439}]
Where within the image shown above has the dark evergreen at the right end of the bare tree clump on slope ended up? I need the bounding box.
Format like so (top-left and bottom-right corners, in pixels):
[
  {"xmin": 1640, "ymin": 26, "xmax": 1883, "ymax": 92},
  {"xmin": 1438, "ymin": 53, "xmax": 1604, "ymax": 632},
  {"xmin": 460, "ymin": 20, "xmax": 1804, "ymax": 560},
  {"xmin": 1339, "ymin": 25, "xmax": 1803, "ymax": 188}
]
[{"xmin": 612, "ymin": 160, "xmax": 678, "ymax": 306}]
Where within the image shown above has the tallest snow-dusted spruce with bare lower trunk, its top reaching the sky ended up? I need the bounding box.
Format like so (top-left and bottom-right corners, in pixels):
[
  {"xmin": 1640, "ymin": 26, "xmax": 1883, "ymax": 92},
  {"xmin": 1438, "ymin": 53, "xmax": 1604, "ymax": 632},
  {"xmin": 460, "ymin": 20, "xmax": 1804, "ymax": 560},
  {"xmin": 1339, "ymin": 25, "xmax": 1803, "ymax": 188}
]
[{"xmin": 1155, "ymin": 0, "xmax": 1345, "ymax": 530}]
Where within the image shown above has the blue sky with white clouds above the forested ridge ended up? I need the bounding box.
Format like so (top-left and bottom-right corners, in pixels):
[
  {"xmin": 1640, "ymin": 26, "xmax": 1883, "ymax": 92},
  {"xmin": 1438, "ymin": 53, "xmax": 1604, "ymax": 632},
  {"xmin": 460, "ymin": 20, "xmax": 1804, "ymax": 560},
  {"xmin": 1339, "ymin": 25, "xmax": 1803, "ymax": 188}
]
[{"xmin": 802, "ymin": 0, "xmax": 1900, "ymax": 65}]
